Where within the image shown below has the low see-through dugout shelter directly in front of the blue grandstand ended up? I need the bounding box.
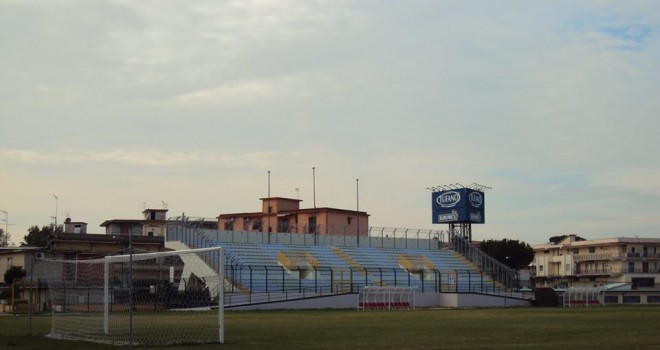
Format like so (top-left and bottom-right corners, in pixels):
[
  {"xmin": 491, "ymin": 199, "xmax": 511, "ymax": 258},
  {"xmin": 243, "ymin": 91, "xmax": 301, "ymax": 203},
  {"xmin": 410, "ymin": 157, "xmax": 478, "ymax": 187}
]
[{"xmin": 357, "ymin": 286, "xmax": 415, "ymax": 310}]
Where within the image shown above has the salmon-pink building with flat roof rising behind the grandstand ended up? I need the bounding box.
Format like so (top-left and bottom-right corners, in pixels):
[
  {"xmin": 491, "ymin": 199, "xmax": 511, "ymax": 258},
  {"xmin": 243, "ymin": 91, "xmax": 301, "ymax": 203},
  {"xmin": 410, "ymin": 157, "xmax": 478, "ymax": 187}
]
[{"xmin": 218, "ymin": 197, "xmax": 369, "ymax": 236}]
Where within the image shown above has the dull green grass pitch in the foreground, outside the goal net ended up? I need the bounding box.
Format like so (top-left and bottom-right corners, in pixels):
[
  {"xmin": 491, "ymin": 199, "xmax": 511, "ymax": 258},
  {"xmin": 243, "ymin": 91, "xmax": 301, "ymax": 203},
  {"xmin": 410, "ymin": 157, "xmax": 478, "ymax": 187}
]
[{"xmin": 0, "ymin": 306, "xmax": 660, "ymax": 350}]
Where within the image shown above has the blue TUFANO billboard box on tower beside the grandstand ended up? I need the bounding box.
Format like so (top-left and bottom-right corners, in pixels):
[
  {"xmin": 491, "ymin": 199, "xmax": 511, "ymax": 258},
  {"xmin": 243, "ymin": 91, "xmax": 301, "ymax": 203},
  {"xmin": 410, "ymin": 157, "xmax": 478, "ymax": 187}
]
[{"xmin": 431, "ymin": 188, "xmax": 486, "ymax": 224}]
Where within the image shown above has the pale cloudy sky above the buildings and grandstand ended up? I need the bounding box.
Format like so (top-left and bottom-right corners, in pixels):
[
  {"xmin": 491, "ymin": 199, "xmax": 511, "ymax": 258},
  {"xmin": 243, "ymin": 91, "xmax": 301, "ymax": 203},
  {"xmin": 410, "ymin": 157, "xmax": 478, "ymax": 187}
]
[{"xmin": 0, "ymin": 0, "xmax": 660, "ymax": 244}]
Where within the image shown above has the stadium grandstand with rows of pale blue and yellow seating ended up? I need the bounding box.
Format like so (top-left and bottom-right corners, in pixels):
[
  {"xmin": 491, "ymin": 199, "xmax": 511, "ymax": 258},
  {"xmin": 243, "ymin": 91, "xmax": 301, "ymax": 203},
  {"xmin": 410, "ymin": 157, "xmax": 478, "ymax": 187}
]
[{"xmin": 166, "ymin": 217, "xmax": 529, "ymax": 309}]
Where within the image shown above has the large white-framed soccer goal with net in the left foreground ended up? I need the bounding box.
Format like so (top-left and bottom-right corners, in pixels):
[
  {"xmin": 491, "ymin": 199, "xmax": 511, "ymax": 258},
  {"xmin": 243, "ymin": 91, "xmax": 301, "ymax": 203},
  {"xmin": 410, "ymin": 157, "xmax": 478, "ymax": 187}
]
[{"xmin": 34, "ymin": 247, "xmax": 224, "ymax": 346}]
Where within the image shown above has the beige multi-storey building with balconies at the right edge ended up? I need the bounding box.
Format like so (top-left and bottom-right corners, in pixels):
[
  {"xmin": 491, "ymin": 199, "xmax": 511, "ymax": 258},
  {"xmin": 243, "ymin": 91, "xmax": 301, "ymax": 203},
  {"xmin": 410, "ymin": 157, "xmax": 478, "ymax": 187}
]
[{"xmin": 530, "ymin": 235, "xmax": 660, "ymax": 290}]
